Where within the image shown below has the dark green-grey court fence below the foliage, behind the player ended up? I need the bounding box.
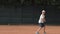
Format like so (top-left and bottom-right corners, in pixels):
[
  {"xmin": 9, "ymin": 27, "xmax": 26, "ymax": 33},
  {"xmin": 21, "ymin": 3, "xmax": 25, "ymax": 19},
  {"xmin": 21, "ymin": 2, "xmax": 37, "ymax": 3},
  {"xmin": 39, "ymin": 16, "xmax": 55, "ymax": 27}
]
[{"xmin": 0, "ymin": 6, "xmax": 60, "ymax": 25}]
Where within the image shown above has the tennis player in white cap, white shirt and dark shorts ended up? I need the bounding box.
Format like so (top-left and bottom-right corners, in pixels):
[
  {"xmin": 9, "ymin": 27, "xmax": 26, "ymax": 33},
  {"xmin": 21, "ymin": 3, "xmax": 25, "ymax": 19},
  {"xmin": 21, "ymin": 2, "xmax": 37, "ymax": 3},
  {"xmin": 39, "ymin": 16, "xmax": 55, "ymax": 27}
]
[{"xmin": 36, "ymin": 10, "xmax": 46, "ymax": 34}]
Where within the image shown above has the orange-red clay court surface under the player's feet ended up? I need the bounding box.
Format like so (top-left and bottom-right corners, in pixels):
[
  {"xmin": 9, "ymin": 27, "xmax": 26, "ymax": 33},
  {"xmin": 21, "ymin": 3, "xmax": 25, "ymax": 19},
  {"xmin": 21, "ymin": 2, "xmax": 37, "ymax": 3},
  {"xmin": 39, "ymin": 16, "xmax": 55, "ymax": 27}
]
[{"xmin": 0, "ymin": 25, "xmax": 60, "ymax": 34}]
